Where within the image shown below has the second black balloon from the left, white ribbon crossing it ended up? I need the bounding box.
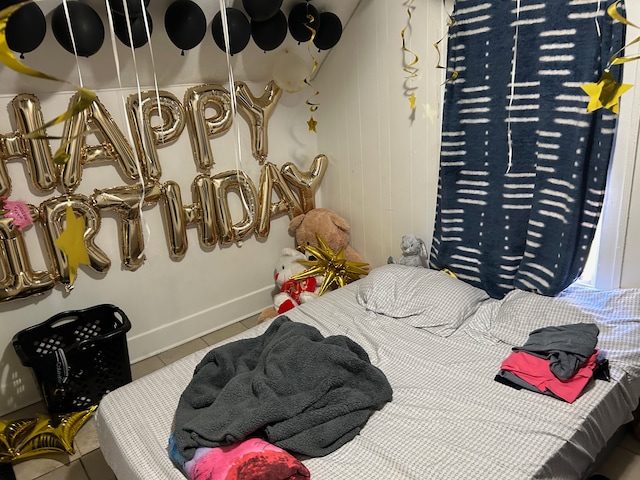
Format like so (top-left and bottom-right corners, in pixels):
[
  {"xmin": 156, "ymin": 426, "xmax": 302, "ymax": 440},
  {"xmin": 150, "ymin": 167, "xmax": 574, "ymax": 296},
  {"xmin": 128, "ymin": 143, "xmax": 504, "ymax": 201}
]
[{"xmin": 51, "ymin": 0, "xmax": 104, "ymax": 57}]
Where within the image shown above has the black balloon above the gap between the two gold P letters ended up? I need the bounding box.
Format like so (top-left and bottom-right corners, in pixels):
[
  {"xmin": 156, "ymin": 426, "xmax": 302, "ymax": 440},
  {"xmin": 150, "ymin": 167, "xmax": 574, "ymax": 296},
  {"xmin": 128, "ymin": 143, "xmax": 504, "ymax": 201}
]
[{"xmin": 164, "ymin": 0, "xmax": 207, "ymax": 50}]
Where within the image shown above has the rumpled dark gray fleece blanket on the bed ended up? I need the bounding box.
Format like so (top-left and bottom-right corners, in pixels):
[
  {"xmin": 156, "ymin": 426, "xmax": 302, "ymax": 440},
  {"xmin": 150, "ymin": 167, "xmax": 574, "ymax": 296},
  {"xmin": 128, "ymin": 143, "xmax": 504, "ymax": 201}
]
[{"xmin": 173, "ymin": 316, "xmax": 392, "ymax": 460}]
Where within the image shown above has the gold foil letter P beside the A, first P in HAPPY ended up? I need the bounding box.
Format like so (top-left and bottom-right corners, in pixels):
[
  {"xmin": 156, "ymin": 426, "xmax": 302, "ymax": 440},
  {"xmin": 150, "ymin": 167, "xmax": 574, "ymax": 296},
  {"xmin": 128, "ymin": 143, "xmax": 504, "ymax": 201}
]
[{"xmin": 127, "ymin": 90, "xmax": 185, "ymax": 179}]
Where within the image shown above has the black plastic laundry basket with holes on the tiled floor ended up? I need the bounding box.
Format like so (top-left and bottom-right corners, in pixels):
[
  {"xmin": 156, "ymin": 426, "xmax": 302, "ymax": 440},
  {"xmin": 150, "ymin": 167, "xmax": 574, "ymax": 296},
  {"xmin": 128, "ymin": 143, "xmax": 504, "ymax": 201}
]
[{"xmin": 13, "ymin": 304, "xmax": 131, "ymax": 414}]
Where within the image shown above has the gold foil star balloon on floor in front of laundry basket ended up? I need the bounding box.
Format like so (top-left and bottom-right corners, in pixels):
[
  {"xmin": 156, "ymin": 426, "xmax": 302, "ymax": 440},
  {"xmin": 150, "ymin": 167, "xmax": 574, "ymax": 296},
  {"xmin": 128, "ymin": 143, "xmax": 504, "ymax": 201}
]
[{"xmin": 0, "ymin": 405, "xmax": 97, "ymax": 463}]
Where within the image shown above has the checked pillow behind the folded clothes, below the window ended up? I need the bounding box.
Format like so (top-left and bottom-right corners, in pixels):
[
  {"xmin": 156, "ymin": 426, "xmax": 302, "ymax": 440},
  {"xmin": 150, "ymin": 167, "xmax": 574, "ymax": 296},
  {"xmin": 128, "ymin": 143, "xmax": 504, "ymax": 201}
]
[{"xmin": 490, "ymin": 284, "xmax": 640, "ymax": 363}]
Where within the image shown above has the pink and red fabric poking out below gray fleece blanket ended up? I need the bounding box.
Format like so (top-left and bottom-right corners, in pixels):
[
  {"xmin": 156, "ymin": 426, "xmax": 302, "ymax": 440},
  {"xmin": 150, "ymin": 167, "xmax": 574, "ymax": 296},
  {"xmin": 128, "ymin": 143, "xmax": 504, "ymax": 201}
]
[{"xmin": 183, "ymin": 438, "xmax": 311, "ymax": 480}]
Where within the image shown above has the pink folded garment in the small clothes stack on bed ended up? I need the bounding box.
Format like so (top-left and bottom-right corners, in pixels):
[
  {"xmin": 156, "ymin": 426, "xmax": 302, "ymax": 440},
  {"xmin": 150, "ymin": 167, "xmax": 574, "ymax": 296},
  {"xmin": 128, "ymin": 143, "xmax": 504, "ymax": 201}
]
[{"xmin": 500, "ymin": 350, "xmax": 598, "ymax": 403}]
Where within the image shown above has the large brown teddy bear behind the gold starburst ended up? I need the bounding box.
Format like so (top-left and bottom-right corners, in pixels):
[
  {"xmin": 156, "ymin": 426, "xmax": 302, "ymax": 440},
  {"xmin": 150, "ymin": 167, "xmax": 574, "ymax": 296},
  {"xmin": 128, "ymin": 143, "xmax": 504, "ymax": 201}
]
[{"xmin": 289, "ymin": 208, "xmax": 366, "ymax": 263}]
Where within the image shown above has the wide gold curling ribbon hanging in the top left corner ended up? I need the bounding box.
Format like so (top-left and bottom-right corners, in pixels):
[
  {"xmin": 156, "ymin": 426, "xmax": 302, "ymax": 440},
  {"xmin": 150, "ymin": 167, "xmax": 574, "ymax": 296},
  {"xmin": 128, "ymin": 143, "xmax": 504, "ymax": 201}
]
[{"xmin": 0, "ymin": 2, "xmax": 98, "ymax": 164}]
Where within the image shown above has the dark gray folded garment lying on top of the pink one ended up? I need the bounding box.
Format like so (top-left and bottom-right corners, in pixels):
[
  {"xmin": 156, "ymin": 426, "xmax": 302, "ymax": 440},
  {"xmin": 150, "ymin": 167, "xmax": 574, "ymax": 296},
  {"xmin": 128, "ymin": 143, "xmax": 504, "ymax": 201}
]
[{"xmin": 512, "ymin": 323, "xmax": 600, "ymax": 380}]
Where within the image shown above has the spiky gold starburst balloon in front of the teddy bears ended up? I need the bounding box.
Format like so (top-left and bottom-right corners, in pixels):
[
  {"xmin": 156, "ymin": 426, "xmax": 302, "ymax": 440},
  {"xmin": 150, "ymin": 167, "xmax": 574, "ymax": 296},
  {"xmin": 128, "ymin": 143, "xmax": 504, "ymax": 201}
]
[{"xmin": 291, "ymin": 234, "xmax": 368, "ymax": 295}]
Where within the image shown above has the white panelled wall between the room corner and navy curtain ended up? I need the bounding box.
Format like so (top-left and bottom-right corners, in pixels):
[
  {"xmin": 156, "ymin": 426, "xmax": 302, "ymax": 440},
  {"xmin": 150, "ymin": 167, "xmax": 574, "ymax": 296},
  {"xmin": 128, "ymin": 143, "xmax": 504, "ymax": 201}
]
[{"xmin": 316, "ymin": 0, "xmax": 445, "ymax": 265}]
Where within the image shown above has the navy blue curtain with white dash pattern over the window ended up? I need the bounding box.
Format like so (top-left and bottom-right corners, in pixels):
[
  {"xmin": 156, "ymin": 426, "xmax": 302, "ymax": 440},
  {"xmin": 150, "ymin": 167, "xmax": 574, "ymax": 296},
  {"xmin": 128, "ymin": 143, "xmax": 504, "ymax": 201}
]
[{"xmin": 430, "ymin": 0, "xmax": 624, "ymax": 298}]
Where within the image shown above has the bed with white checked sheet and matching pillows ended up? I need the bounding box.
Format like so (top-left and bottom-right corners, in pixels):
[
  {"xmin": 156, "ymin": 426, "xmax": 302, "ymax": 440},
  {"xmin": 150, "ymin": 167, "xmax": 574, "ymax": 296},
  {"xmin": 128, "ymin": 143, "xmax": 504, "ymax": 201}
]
[{"xmin": 96, "ymin": 265, "xmax": 640, "ymax": 480}]
